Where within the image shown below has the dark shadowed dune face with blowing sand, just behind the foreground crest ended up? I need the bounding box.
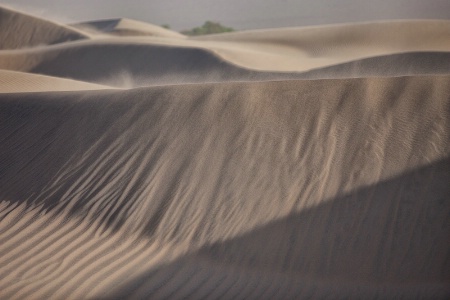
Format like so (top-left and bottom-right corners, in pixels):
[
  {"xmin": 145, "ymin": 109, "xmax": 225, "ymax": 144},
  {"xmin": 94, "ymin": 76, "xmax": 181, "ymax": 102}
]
[{"xmin": 31, "ymin": 44, "xmax": 450, "ymax": 87}]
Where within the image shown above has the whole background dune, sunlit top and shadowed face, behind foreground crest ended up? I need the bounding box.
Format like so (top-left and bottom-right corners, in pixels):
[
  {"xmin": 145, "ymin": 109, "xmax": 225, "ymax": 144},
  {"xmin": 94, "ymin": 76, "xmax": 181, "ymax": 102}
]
[{"xmin": 0, "ymin": 21, "xmax": 450, "ymax": 88}]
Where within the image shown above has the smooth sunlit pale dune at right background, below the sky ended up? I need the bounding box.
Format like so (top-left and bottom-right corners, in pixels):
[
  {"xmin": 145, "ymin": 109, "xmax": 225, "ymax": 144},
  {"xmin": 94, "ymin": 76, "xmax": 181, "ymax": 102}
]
[{"xmin": 192, "ymin": 21, "xmax": 450, "ymax": 71}]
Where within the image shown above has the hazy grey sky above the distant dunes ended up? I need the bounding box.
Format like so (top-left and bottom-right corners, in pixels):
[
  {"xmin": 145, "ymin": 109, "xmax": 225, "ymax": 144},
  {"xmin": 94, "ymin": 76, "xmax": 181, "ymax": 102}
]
[{"xmin": 0, "ymin": 0, "xmax": 450, "ymax": 30}]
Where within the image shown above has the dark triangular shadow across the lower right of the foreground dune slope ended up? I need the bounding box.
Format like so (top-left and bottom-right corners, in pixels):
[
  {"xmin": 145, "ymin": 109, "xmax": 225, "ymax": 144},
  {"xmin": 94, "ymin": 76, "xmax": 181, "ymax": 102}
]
[{"xmin": 107, "ymin": 158, "xmax": 450, "ymax": 299}]
